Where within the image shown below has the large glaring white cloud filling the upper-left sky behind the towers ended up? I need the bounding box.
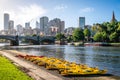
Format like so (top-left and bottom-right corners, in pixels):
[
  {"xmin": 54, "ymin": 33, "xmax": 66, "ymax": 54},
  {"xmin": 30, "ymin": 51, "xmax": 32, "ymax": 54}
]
[{"xmin": 0, "ymin": 0, "xmax": 47, "ymax": 30}]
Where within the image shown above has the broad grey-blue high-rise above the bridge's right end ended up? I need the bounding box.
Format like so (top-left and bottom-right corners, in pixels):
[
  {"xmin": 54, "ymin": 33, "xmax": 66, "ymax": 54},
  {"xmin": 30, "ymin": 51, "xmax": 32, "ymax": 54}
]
[{"xmin": 40, "ymin": 16, "xmax": 49, "ymax": 33}]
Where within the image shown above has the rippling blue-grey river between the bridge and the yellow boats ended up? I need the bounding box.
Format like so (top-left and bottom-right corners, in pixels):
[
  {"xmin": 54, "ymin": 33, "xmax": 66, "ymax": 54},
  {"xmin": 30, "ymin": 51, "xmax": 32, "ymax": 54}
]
[{"xmin": 2, "ymin": 45, "xmax": 120, "ymax": 76}]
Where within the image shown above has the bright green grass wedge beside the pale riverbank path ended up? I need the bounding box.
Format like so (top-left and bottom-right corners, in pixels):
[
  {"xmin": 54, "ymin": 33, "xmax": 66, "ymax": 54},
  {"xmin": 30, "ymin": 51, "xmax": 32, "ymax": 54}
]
[{"xmin": 0, "ymin": 56, "xmax": 33, "ymax": 80}]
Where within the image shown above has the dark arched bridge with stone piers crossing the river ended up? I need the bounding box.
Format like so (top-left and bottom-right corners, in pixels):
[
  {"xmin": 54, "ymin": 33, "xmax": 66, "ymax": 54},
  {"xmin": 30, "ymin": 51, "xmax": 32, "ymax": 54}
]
[{"xmin": 0, "ymin": 35, "xmax": 55, "ymax": 46}]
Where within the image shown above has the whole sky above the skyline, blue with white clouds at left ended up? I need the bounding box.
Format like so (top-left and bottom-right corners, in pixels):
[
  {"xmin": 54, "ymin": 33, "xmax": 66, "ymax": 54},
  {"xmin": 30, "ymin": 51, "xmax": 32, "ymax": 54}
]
[{"xmin": 0, "ymin": 0, "xmax": 120, "ymax": 30}]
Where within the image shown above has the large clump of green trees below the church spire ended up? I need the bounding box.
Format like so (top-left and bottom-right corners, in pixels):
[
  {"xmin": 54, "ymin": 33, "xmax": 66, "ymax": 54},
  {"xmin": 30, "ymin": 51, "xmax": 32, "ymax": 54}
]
[{"xmin": 91, "ymin": 22, "xmax": 120, "ymax": 42}]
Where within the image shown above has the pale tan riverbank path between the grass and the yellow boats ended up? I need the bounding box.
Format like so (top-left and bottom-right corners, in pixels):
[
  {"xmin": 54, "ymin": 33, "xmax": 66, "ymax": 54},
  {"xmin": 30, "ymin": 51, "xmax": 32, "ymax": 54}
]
[{"xmin": 0, "ymin": 50, "xmax": 120, "ymax": 80}]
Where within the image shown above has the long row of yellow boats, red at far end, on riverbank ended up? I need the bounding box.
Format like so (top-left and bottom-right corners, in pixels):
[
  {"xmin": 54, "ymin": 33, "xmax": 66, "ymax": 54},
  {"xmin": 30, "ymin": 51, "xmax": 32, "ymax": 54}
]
[{"xmin": 17, "ymin": 55, "xmax": 107, "ymax": 76}]
